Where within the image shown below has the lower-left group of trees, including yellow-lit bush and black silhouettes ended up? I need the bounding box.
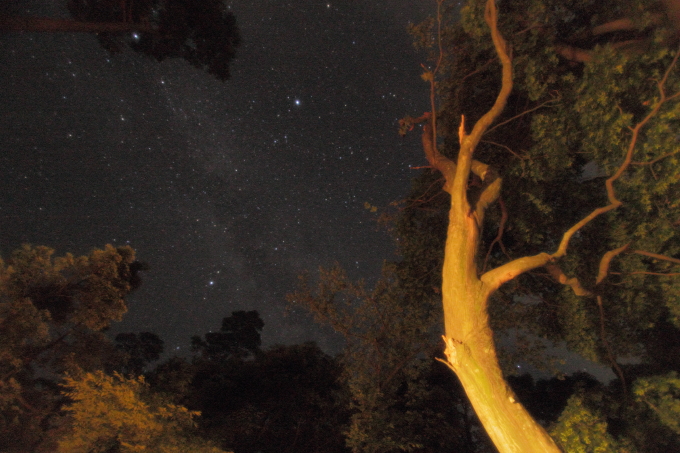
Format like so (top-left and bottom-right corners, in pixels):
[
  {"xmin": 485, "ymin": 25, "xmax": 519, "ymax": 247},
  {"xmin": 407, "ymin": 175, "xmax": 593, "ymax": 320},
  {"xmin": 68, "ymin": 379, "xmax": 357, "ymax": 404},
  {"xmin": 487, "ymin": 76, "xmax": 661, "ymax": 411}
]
[{"xmin": 0, "ymin": 245, "xmax": 349, "ymax": 453}]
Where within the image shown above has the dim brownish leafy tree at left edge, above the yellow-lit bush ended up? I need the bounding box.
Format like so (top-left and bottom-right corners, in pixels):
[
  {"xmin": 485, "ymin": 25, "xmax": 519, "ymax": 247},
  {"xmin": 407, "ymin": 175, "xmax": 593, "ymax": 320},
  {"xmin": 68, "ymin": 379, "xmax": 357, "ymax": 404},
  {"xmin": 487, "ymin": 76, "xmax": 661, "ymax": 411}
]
[{"xmin": 0, "ymin": 245, "xmax": 144, "ymax": 452}]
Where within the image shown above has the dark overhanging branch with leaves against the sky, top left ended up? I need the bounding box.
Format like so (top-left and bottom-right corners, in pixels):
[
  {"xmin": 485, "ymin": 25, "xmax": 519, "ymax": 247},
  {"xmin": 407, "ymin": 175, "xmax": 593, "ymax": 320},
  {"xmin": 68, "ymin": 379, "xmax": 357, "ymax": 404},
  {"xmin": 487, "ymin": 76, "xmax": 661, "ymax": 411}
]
[{"xmin": 0, "ymin": 0, "xmax": 241, "ymax": 81}]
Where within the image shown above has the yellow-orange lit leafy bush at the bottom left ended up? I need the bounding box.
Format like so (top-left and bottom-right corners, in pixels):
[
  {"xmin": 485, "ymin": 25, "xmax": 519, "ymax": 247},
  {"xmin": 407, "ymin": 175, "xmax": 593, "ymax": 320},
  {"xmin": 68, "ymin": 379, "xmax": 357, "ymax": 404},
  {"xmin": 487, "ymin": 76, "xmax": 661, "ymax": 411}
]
[{"xmin": 59, "ymin": 371, "xmax": 228, "ymax": 453}]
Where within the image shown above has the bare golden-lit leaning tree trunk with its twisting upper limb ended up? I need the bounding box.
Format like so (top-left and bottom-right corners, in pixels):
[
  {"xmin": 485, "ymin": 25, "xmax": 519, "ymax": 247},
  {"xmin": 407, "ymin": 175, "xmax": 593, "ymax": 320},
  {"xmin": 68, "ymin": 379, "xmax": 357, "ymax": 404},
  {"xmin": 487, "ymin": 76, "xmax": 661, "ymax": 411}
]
[{"xmin": 423, "ymin": 0, "xmax": 560, "ymax": 453}]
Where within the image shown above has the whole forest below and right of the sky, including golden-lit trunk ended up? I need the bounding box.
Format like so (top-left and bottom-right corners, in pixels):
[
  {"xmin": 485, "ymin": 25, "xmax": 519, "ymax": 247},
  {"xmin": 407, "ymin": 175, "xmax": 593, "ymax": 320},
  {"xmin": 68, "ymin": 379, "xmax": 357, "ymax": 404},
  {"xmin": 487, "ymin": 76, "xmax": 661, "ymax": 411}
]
[{"xmin": 0, "ymin": 0, "xmax": 680, "ymax": 453}]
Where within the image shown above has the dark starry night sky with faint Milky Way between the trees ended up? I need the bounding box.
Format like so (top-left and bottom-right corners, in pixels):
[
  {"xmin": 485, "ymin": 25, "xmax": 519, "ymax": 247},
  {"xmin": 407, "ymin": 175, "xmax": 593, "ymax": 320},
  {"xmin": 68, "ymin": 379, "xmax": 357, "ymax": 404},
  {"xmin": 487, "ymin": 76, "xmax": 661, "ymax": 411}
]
[{"xmin": 0, "ymin": 0, "xmax": 435, "ymax": 355}]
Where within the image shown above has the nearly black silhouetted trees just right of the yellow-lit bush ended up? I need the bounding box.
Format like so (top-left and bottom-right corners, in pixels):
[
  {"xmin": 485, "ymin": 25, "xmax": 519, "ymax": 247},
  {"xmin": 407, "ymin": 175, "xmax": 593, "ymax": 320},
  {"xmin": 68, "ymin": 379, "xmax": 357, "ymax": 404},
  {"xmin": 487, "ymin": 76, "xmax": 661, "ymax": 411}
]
[{"xmin": 149, "ymin": 311, "xmax": 350, "ymax": 453}]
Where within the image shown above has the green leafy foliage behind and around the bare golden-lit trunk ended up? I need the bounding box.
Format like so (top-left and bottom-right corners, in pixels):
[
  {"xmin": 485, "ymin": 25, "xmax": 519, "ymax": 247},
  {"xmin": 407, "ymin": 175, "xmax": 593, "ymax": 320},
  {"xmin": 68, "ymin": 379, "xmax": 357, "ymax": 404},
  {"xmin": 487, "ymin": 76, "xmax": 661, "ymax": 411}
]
[{"xmin": 289, "ymin": 0, "xmax": 680, "ymax": 446}]
